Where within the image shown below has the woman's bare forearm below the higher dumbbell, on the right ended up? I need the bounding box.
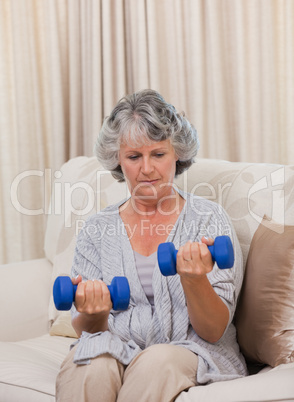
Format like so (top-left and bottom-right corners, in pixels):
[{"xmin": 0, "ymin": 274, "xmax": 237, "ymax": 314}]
[{"xmin": 181, "ymin": 276, "xmax": 229, "ymax": 343}]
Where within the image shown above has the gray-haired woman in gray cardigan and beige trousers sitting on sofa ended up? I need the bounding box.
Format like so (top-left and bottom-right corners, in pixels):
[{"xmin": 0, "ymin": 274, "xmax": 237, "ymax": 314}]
[{"xmin": 57, "ymin": 90, "xmax": 246, "ymax": 402}]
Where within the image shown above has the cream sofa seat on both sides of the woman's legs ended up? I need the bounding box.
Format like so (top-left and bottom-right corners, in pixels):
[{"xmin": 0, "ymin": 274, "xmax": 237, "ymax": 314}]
[{"xmin": 0, "ymin": 335, "xmax": 294, "ymax": 402}]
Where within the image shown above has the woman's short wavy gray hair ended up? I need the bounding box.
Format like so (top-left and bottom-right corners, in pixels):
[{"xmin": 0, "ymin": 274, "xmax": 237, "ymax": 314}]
[{"xmin": 94, "ymin": 89, "xmax": 199, "ymax": 182}]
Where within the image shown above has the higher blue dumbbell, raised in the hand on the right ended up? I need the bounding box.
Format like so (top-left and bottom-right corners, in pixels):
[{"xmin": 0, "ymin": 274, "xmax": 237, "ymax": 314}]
[{"xmin": 157, "ymin": 236, "xmax": 235, "ymax": 276}]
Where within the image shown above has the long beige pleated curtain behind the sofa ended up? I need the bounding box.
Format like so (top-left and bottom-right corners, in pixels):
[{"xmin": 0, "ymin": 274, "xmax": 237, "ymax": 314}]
[{"xmin": 0, "ymin": 0, "xmax": 294, "ymax": 262}]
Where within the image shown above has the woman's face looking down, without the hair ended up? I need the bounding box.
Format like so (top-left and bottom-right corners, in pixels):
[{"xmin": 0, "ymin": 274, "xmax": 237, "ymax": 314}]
[{"xmin": 119, "ymin": 140, "xmax": 178, "ymax": 201}]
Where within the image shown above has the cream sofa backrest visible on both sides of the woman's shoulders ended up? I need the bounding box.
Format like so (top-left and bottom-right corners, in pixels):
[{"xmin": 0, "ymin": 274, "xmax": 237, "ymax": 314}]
[{"xmin": 45, "ymin": 157, "xmax": 294, "ymax": 286}]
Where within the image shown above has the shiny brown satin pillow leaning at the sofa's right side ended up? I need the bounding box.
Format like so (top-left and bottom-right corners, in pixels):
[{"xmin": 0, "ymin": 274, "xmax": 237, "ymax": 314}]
[{"xmin": 236, "ymin": 217, "xmax": 294, "ymax": 367}]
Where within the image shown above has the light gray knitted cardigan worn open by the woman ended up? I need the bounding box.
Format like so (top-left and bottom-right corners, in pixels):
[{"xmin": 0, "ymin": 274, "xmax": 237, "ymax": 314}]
[{"xmin": 72, "ymin": 192, "xmax": 247, "ymax": 384}]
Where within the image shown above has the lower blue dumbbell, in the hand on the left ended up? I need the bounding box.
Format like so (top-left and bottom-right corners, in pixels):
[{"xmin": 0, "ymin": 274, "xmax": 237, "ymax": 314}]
[{"xmin": 53, "ymin": 276, "xmax": 130, "ymax": 310}]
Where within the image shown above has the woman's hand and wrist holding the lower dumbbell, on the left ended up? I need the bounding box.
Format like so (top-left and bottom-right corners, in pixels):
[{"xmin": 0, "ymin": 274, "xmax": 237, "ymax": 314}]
[{"xmin": 72, "ymin": 275, "xmax": 112, "ymax": 333}]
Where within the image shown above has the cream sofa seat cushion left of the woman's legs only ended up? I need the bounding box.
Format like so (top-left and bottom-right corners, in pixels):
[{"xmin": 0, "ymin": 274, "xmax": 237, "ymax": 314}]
[{"xmin": 0, "ymin": 335, "xmax": 75, "ymax": 402}]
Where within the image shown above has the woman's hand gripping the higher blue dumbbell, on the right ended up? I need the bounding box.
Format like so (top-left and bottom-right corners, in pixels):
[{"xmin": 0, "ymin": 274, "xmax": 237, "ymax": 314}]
[{"xmin": 177, "ymin": 237, "xmax": 214, "ymax": 279}]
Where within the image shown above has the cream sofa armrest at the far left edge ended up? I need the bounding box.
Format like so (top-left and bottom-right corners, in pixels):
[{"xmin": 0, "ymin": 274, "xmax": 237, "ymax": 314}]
[{"xmin": 0, "ymin": 258, "xmax": 52, "ymax": 341}]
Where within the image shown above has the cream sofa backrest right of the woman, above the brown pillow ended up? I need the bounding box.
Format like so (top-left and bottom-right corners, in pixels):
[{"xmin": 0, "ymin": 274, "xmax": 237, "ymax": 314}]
[{"xmin": 177, "ymin": 159, "xmax": 294, "ymax": 264}]
